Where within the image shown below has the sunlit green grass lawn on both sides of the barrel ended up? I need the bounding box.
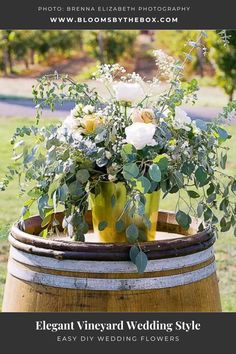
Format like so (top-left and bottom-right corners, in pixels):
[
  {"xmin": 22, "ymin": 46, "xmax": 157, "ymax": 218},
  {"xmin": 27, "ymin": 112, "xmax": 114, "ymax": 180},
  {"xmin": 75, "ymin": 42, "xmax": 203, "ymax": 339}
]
[{"xmin": 0, "ymin": 118, "xmax": 236, "ymax": 311}]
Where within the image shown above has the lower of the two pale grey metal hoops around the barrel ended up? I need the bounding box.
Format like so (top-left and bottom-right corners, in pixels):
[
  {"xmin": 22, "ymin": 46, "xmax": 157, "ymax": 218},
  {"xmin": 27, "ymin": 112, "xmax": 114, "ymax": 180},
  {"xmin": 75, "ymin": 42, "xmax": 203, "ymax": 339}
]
[{"xmin": 8, "ymin": 261, "xmax": 216, "ymax": 291}]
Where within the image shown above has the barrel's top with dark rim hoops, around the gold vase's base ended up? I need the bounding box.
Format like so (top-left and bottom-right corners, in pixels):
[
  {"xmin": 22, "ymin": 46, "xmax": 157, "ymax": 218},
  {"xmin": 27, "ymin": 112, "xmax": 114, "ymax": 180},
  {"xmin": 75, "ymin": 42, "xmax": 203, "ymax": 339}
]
[{"xmin": 9, "ymin": 211, "xmax": 215, "ymax": 261}]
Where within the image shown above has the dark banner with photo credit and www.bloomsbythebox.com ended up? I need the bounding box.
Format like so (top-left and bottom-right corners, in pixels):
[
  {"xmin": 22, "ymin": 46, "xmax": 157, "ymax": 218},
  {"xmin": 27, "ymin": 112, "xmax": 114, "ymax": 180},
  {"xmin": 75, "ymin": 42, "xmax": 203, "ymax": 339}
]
[{"xmin": 0, "ymin": 0, "xmax": 236, "ymax": 29}]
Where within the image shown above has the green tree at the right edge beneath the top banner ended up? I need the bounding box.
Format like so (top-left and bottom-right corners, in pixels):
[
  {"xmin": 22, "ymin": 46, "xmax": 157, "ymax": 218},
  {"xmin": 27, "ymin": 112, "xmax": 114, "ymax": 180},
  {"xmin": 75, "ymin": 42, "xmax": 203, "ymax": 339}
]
[{"xmin": 213, "ymin": 31, "xmax": 236, "ymax": 101}]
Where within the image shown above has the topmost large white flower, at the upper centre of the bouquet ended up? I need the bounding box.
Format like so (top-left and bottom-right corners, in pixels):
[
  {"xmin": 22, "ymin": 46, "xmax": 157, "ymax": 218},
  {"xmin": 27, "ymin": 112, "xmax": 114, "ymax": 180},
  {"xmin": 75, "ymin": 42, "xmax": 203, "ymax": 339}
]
[{"xmin": 113, "ymin": 82, "xmax": 145, "ymax": 103}]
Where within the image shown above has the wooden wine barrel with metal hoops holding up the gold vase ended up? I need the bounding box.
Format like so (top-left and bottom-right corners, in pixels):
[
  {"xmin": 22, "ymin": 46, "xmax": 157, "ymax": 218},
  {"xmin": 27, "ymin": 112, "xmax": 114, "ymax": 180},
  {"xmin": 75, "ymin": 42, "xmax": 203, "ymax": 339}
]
[{"xmin": 3, "ymin": 212, "xmax": 221, "ymax": 312}]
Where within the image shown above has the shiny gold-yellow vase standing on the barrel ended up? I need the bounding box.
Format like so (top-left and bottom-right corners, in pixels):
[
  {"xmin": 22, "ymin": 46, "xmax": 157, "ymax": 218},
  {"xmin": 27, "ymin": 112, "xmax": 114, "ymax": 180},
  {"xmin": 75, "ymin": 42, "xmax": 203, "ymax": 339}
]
[{"xmin": 90, "ymin": 182, "xmax": 160, "ymax": 243}]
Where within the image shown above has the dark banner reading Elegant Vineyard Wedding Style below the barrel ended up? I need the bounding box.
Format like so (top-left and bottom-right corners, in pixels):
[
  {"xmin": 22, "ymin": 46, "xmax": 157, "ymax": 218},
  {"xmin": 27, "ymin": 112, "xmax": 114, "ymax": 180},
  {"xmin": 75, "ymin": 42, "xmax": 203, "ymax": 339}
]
[{"xmin": 0, "ymin": 313, "xmax": 236, "ymax": 353}]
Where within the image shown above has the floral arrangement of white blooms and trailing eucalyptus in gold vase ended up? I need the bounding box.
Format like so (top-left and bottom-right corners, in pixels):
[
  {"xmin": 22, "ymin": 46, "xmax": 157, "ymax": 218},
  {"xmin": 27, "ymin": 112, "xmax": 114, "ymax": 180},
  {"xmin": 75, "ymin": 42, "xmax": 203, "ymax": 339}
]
[{"xmin": 2, "ymin": 33, "xmax": 236, "ymax": 271}]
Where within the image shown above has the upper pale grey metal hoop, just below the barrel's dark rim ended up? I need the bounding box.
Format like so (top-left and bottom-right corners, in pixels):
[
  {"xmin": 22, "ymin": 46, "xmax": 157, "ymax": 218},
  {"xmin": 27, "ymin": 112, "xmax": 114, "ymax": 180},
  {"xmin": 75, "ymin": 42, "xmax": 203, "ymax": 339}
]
[{"xmin": 10, "ymin": 247, "xmax": 214, "ymax": 273}]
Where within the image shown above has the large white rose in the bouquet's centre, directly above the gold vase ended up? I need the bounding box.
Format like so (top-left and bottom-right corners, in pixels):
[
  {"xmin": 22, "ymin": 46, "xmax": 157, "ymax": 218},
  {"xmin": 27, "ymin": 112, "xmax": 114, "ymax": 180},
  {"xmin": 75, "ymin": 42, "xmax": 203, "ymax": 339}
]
[{"xmin": 125, "ymin": 122, "xmax": 156, "ymax": 150}]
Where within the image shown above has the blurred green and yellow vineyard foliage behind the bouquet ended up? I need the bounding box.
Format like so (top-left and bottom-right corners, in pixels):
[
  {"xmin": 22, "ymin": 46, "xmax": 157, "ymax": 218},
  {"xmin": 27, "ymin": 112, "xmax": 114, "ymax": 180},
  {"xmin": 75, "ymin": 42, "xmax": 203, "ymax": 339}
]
[{"xmin": 0, "ymin": 30, "xmax": 236, "ymax": 100}]
